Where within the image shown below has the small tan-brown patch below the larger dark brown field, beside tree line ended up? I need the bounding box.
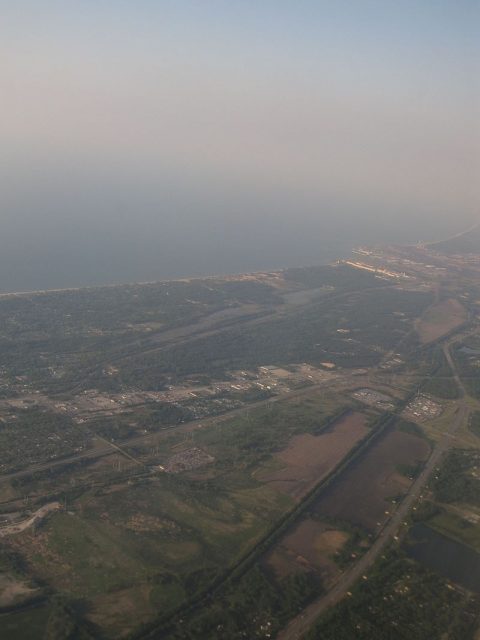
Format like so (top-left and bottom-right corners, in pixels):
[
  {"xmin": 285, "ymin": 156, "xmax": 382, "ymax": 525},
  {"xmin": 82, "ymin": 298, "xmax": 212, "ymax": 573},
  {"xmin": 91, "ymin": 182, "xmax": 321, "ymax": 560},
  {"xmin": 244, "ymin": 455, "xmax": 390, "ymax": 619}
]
[{"xmin": 267, "ymin": 519, "xmax": 348, "ymax": 585}]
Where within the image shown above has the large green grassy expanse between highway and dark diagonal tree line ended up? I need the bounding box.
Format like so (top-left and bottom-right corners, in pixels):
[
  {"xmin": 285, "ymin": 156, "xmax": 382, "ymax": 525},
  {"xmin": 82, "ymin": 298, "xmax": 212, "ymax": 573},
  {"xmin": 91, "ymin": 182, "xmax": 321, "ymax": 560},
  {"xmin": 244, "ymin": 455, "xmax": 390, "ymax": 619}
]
[{"xmin": 0, "ymin": 391, "xmax": 356, "ymax": 638}]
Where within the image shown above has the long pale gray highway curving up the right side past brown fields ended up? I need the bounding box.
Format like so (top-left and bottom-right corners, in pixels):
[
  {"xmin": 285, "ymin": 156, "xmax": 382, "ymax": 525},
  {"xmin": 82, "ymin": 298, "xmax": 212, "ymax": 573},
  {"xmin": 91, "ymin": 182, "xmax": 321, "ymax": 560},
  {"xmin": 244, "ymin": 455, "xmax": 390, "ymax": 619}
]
[{"xmin": 277, "ymin": 346, "xmax": 470, "ymax": 640}]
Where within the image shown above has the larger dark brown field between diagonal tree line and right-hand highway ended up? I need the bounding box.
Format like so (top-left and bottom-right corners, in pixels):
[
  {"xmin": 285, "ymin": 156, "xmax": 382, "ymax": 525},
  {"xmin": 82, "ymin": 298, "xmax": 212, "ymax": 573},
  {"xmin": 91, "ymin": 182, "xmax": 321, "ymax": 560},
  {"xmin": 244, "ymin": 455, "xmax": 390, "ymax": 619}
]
[{"xmin": 314, "ymin": 429, "xmax": 430, "ymax": 531}]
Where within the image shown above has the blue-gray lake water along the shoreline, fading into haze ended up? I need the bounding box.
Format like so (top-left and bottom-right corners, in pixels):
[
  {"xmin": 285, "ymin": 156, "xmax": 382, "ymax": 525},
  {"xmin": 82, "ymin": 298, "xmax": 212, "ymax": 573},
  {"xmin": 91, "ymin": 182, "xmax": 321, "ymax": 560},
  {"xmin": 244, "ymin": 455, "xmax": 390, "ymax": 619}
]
[{"xmin": 0, "ymin": 199, "xmax": 464, "ymax": 292}]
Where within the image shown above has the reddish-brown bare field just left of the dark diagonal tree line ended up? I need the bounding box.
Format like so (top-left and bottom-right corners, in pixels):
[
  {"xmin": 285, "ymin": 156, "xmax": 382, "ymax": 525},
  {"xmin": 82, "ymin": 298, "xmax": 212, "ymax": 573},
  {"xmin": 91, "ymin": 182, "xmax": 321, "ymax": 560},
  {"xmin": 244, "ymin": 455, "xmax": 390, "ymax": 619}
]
[{"xmin": 257, "ymin": 412, "xmax": 368, "ymax": 500}]
